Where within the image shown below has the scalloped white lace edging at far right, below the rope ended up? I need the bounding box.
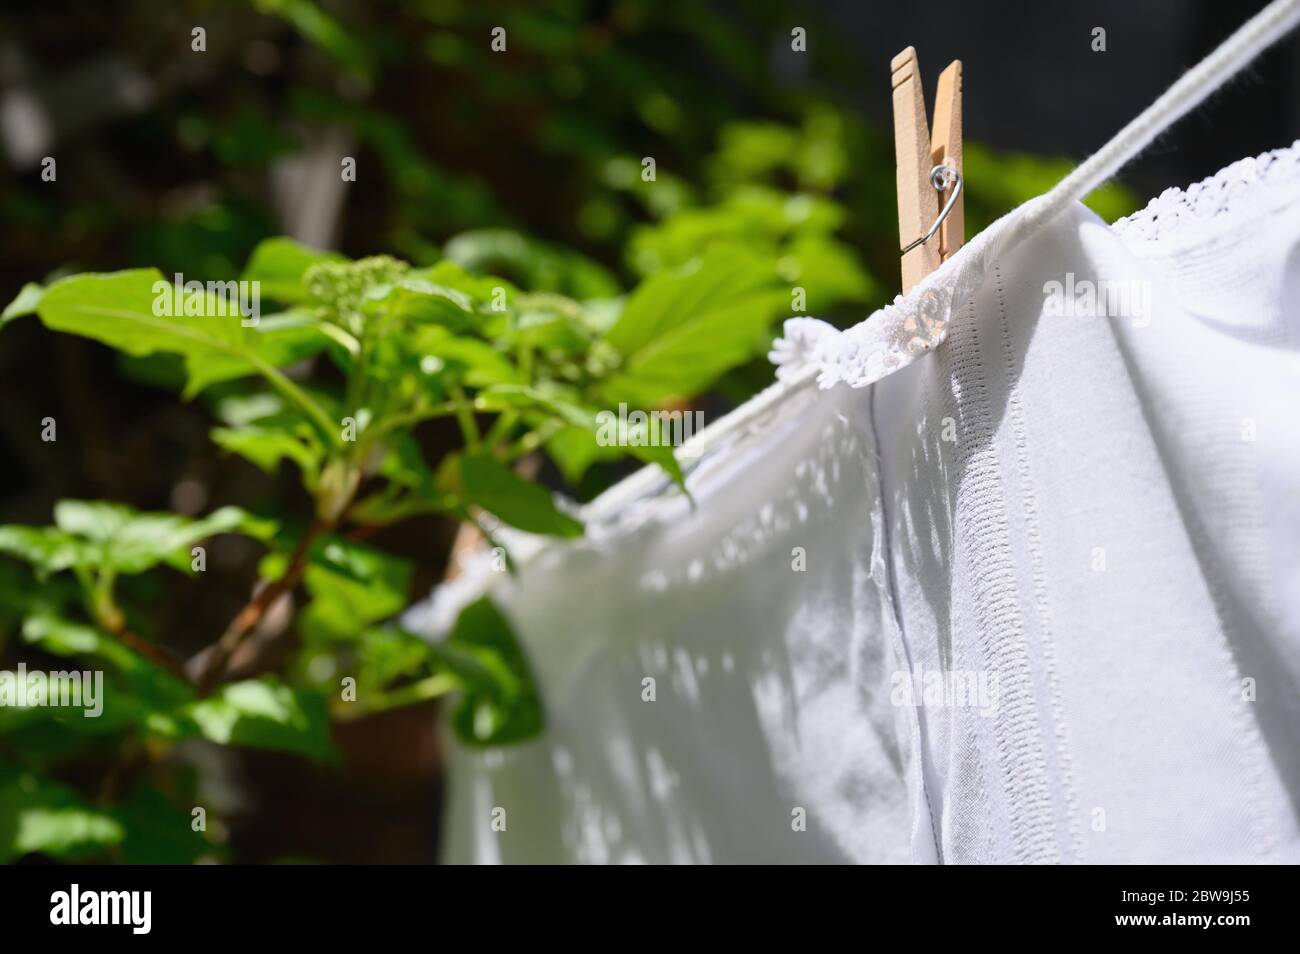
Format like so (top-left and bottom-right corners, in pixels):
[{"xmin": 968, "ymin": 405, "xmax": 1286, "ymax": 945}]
[{"xmin": 1112, "ymin": 139, "xmax": 1300, "ymax": 248}]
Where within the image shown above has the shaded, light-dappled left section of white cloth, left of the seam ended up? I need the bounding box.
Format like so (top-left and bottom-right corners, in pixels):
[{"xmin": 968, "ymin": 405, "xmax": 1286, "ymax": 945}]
[{"xmin": 443, "ymin": 390, "xmax": 928, "ymax": 862}]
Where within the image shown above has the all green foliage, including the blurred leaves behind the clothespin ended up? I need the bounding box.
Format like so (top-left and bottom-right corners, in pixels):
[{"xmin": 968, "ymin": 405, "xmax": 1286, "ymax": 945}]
[{"xmin": 0, "ymin": 55, "xmax": 1125, "ymax": 860}]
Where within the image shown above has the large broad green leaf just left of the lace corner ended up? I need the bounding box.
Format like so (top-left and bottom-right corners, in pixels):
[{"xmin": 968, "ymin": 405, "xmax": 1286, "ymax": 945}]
[{"xmin": 602, "ymin": 250, "xmax": 788, "ymax": 407}]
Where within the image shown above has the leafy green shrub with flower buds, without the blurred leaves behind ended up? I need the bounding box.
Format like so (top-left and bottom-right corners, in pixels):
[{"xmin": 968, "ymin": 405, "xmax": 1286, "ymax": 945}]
[{"xmin": 0, "ymin": 220, "xmax": 821, "ymax": 857}]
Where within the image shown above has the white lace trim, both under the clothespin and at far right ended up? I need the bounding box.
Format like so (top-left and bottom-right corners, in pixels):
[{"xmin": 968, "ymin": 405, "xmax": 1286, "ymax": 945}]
[{"xmin": 768, "ymin": 140, "xmax": 1300, "ymax": 389}]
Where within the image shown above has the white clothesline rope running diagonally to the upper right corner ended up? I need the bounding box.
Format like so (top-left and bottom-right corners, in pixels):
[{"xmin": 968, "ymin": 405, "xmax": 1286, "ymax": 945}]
[{"xmin": 582, "ymin": 0, "xmax": 1300, "ymax": 520}]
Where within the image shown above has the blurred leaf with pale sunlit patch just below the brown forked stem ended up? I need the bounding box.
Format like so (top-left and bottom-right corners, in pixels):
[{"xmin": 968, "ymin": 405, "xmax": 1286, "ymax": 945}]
[{"xmin": 183, "ymin": 677, "xmax": 335, "ymax": 760}]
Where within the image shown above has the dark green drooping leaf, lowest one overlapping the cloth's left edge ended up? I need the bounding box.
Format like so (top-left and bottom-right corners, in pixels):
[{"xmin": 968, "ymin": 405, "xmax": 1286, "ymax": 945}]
[{"xmin": 434, "ymin": 597, "xmax": 545, "ymax": 746}]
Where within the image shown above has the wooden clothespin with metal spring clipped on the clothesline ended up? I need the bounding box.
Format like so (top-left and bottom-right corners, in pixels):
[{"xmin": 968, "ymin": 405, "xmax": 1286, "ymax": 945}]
[{"xmin": 889, "ymin": 47, "xmax": 966, "ymax": 295}]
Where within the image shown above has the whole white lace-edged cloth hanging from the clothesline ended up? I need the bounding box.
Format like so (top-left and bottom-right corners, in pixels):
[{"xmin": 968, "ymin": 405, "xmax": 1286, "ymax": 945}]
[{"xmin": 431, "ymin": 143, "xmax": 1300, "ymax": 862}]
